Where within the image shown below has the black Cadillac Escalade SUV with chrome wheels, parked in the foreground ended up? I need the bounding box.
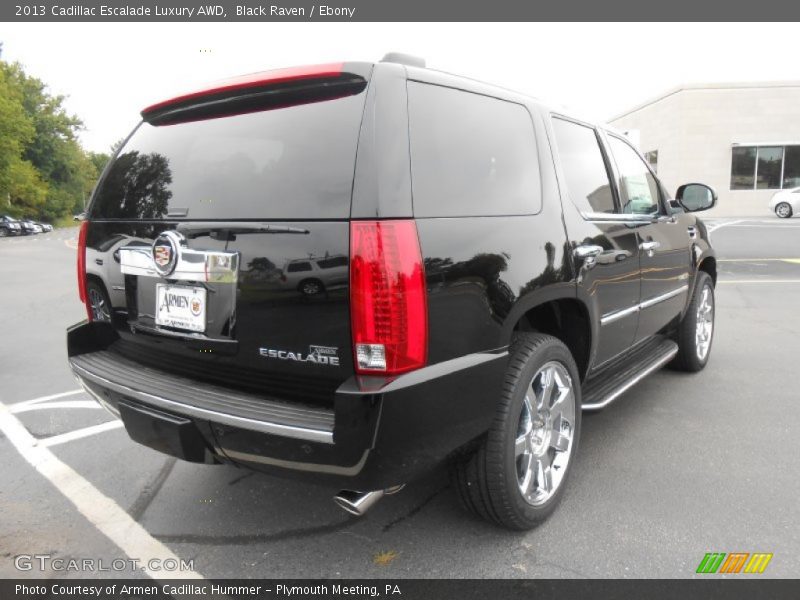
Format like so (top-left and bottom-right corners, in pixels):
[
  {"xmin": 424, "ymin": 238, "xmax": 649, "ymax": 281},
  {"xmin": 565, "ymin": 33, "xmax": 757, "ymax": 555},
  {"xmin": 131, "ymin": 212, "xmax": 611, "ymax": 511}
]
[{"xmin": 68, "ymin": 55, "xmax": 716, "ymax": 529}]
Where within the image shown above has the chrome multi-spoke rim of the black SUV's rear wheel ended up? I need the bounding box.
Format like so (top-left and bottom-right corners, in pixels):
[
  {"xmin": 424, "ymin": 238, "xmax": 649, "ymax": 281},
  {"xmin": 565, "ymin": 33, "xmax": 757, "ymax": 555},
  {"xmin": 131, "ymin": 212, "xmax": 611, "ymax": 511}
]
[{"xmin": 514, "ymin": 361, "xmax": 575, "ymax": 506}]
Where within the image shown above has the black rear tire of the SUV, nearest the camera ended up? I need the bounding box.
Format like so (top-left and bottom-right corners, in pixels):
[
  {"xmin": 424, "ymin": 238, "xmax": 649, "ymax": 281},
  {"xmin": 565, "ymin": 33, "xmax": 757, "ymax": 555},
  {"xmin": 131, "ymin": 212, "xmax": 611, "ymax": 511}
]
[{"xmin": 451, "ymin": 333, "xmax": 581, "ymax": 530}]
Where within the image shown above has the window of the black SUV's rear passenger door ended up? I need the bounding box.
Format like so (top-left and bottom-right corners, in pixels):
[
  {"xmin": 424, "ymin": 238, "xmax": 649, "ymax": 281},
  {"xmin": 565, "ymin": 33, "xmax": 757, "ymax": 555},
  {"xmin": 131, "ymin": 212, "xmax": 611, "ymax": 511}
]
[{"xmin": 553, "ymin": 119, "xmax": 614, "ymax": 213}]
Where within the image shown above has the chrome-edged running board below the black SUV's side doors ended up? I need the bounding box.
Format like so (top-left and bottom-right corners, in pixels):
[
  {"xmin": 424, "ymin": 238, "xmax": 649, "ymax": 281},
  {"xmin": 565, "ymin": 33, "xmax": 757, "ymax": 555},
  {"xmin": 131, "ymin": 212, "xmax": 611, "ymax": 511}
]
[{"xmin": 582, "ymin": 339, "xmax": 678, "ymax": 411}]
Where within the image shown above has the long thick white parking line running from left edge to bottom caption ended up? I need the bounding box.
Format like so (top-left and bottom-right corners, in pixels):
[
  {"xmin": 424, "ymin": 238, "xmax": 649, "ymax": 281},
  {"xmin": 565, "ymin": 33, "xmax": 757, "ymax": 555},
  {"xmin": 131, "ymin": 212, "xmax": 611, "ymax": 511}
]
[{"xmin": 0, "ymin": 402, "xmax": 202, "ymax": 579}]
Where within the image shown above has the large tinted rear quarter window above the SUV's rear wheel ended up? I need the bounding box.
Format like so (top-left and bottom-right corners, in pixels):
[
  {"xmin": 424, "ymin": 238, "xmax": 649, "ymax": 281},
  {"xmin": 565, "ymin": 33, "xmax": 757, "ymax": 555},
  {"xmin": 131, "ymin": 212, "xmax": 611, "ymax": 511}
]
[{"xmin": 408, "ymin": 81, "xmax": 541, "ymax": 217}]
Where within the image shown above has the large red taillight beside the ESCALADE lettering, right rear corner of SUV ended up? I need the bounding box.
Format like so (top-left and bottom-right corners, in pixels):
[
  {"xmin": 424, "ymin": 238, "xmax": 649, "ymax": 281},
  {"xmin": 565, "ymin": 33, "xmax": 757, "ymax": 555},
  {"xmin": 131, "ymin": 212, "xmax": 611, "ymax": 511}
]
[{"xmin": 350, "ymin": 221, "xmax": 428, "ymax": 375}]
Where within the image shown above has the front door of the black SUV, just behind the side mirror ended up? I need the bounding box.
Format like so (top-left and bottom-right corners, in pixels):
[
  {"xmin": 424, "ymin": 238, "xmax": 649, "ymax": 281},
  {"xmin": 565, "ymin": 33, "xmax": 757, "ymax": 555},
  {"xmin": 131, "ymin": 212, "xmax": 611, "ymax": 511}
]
[{"xmin": 606, "ymin": 134, "xmax": 692, "ymax": 341}]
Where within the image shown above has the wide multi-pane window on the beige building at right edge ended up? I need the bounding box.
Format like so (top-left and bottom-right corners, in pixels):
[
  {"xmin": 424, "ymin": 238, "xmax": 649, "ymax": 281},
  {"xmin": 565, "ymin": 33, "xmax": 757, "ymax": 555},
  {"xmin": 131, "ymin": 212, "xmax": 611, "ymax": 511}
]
[{"xmin": 731, "ymin": 145, "xmax": 800, "ymax": 190}]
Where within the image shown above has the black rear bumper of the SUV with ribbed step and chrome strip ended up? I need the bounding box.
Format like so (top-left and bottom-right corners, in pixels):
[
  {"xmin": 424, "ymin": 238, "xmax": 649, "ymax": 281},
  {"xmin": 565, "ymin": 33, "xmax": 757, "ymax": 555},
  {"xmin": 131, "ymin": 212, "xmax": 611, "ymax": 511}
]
[{"xmin": 67, "ymin": 323, "xmax": 507, "ymax": 490}]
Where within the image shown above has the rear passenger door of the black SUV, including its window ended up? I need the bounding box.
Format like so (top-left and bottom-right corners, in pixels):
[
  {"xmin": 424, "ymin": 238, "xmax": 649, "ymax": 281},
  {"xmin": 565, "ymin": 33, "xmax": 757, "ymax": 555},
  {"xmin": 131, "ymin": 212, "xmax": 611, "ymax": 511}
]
[{"xmin": 551, "ymin": 115, "xmax": 640, "ymax": 367}]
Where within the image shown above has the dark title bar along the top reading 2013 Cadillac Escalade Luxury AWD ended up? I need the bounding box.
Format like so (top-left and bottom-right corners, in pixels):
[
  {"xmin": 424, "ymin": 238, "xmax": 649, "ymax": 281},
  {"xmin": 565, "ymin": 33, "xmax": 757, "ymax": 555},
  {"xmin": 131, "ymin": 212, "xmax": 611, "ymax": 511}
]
[{"xmin": 0, "ymin": 0, "xmax": 800, "ymax": 21}]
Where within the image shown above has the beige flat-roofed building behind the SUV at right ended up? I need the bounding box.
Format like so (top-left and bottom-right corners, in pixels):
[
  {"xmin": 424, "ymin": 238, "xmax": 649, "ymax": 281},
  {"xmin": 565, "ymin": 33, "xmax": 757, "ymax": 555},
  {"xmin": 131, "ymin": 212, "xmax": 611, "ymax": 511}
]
[{"xmin": 610, "ymin": 81, "xmax": 800, "ymax": 216}]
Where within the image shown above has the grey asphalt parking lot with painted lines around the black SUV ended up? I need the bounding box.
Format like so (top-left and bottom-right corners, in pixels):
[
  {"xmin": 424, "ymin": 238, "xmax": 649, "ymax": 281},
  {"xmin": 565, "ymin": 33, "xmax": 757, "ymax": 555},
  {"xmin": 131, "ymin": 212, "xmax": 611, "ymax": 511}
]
[{"xmin": 0, "ymin": 217, "xmax": 800, "ymax": 578}]
